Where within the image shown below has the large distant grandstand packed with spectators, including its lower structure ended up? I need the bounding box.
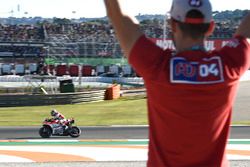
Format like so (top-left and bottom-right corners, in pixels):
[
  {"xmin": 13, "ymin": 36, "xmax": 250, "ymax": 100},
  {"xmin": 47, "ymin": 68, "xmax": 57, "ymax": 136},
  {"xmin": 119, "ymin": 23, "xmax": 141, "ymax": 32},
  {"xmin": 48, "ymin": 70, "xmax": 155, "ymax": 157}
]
[{"xmin": 0, "ymin": 11, "xmax": 247, "ymax": 76}]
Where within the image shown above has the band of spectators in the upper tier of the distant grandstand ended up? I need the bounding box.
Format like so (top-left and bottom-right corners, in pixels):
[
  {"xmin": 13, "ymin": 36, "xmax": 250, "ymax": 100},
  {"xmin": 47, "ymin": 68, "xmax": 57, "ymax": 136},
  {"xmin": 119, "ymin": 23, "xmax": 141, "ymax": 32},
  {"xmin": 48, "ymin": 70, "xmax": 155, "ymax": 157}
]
[{"xmin": 0, "ymin": 20, "xmax": 237, "ymax": 43}]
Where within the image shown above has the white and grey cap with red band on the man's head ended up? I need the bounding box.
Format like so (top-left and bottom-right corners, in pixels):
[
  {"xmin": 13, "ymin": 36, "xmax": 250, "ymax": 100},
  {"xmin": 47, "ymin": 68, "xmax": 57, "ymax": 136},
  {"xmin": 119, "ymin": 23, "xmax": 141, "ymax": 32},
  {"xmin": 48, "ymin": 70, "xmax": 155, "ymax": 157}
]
[{"xmin": 170, "ymin": 0, "xmax": 212, "ymax": 24}]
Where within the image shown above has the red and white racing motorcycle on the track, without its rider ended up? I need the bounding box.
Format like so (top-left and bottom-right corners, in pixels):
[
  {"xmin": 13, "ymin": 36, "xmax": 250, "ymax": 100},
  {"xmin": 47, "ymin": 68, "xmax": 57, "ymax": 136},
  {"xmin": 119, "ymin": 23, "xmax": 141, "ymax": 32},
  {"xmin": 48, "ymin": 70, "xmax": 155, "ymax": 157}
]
[{"xmin": 39, "ymin": 118, "xmax": 81, "ymax": 138}]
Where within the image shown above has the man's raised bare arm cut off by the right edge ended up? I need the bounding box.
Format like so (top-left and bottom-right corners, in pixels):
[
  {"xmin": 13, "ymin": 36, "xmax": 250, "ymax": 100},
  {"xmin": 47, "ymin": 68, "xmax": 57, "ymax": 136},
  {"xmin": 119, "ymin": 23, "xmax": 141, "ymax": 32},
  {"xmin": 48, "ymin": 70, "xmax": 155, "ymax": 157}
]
[{"xmin": 235, "ymin": 13, "xmax": 250, "ymax": 43}]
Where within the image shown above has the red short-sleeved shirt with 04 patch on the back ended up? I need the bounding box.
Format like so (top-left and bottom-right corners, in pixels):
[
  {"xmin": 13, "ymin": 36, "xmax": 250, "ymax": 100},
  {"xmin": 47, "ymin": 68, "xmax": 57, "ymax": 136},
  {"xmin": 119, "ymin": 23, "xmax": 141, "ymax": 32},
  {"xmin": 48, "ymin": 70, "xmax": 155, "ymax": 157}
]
[{"xmin": 129, "ymin": 36, "xmax": 250, "ymax": 167}]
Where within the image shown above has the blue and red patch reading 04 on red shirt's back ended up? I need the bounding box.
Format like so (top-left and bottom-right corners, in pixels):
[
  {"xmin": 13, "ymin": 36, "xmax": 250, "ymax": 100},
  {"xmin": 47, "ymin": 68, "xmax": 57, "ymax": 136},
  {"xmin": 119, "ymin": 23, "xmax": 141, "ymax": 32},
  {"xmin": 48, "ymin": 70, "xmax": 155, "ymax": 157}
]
[{"xmin": 170, "ymin": 57, "xmax": 224, "ymax": 84}]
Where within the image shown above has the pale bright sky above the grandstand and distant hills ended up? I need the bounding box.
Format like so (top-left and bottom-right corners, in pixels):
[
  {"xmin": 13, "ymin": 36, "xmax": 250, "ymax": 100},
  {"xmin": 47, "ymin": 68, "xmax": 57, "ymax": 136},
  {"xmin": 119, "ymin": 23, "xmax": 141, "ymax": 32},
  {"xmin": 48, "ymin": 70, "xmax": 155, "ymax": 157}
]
[{"xmin": 0, "ymin": 0, "xmax": 250, "ymax": 18}]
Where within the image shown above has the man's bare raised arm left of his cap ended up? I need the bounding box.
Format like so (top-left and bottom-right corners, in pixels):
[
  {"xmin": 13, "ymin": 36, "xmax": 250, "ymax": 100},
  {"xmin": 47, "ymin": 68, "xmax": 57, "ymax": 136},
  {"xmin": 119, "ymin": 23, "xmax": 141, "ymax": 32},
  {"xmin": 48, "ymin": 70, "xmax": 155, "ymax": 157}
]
[{"xmin": 104, "ymin": 0, "xmax": 142, "ymax": 58}]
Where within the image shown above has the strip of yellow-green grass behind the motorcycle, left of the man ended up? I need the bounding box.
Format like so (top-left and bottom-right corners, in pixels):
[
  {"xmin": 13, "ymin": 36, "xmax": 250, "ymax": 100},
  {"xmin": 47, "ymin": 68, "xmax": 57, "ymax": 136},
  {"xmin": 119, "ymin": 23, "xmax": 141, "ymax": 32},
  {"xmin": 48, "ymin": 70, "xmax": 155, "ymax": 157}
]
[{"xmin": 0, "ymin": 96, "xmax": 147, "ymax": 126}]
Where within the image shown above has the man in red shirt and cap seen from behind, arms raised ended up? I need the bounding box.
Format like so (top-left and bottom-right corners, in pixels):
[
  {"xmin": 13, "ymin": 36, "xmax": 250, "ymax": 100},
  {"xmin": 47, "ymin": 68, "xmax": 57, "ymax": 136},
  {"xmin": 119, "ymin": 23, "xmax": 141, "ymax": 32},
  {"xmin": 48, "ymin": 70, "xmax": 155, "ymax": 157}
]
[{"xmin": 104, "ymin": 0, "xmax": 250, "ymax": 167}]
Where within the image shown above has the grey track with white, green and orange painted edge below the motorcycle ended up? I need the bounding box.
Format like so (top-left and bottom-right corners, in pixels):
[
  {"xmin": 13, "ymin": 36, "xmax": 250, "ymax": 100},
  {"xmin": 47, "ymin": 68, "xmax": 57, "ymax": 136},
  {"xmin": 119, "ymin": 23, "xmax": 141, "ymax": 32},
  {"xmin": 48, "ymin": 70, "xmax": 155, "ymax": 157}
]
[{"xmin": 0, "ymin": 126, "xmax": 250, "ymax": 167}]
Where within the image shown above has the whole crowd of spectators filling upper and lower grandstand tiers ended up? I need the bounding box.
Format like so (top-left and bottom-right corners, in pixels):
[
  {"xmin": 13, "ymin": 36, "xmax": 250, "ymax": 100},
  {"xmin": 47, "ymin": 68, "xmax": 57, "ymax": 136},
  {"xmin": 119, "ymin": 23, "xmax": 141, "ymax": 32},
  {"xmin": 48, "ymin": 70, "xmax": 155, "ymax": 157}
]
[{"xmin": 0, "ymin": 13, "xmax": 244, "ymax": 57}]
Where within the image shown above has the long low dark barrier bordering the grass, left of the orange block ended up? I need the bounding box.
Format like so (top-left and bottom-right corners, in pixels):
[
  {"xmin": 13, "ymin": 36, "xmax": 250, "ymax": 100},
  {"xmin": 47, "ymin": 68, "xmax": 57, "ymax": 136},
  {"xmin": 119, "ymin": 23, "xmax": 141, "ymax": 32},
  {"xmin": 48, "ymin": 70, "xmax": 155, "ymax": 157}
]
[{"xmin": 0, "ymin": 90, "xmax": 105, "ymax": 107}]
